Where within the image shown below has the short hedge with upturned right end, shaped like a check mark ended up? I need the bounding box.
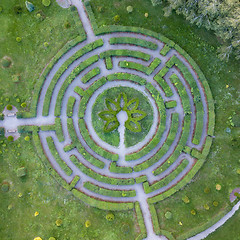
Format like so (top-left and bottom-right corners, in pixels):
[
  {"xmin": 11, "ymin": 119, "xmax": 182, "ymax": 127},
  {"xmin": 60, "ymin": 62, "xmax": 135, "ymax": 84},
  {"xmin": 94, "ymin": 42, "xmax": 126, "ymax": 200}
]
[{"xmin": 119, "ymin": 58, "xmax": 161, "ymax": 75}]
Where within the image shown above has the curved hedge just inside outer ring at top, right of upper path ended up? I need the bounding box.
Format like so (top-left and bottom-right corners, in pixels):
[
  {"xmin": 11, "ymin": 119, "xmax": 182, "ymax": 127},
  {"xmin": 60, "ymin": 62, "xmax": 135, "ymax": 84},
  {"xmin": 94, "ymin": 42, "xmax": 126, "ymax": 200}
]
[{"xmin": 109, "ymin": 37, "xmax": 158, "ymax": 50}]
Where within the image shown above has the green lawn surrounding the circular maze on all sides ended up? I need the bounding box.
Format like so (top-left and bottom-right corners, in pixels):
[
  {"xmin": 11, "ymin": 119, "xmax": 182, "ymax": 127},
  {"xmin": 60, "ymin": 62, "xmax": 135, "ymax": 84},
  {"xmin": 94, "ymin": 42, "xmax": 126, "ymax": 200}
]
[{"xmin": 0, "ymin": 0, "xmax": 240, "ymax": 240}]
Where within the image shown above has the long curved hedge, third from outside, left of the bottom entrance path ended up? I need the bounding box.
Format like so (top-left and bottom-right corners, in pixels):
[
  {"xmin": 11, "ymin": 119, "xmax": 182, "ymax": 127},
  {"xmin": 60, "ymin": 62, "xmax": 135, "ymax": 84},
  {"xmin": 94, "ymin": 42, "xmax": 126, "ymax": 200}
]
[{"xmin": 70, "ymin": 155, "xmax": 135, "ymax": 186}]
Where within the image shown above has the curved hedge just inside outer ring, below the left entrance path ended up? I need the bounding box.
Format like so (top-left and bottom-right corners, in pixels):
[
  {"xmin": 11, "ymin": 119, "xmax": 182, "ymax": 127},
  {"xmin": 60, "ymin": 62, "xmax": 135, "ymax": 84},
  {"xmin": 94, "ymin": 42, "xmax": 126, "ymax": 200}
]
[{"xmin": 46, "ymin": 137, "xmax": 72, "ymax": 176}]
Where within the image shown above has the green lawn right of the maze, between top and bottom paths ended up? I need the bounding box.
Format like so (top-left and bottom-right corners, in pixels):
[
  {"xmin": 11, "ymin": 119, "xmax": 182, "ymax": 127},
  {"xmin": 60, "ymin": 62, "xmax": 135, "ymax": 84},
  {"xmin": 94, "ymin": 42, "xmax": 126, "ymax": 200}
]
[{"xmin": 91, "ymin": 0, "xmax": 240, "ymax": 239}]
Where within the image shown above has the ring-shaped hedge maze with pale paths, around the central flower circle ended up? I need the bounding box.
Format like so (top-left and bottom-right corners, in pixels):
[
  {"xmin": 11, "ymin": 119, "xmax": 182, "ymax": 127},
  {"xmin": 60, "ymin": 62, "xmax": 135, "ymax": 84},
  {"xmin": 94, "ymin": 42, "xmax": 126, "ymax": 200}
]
[{"xmin": 38, "ymin": 33, "xmax": 214, "ymax": 210}]
